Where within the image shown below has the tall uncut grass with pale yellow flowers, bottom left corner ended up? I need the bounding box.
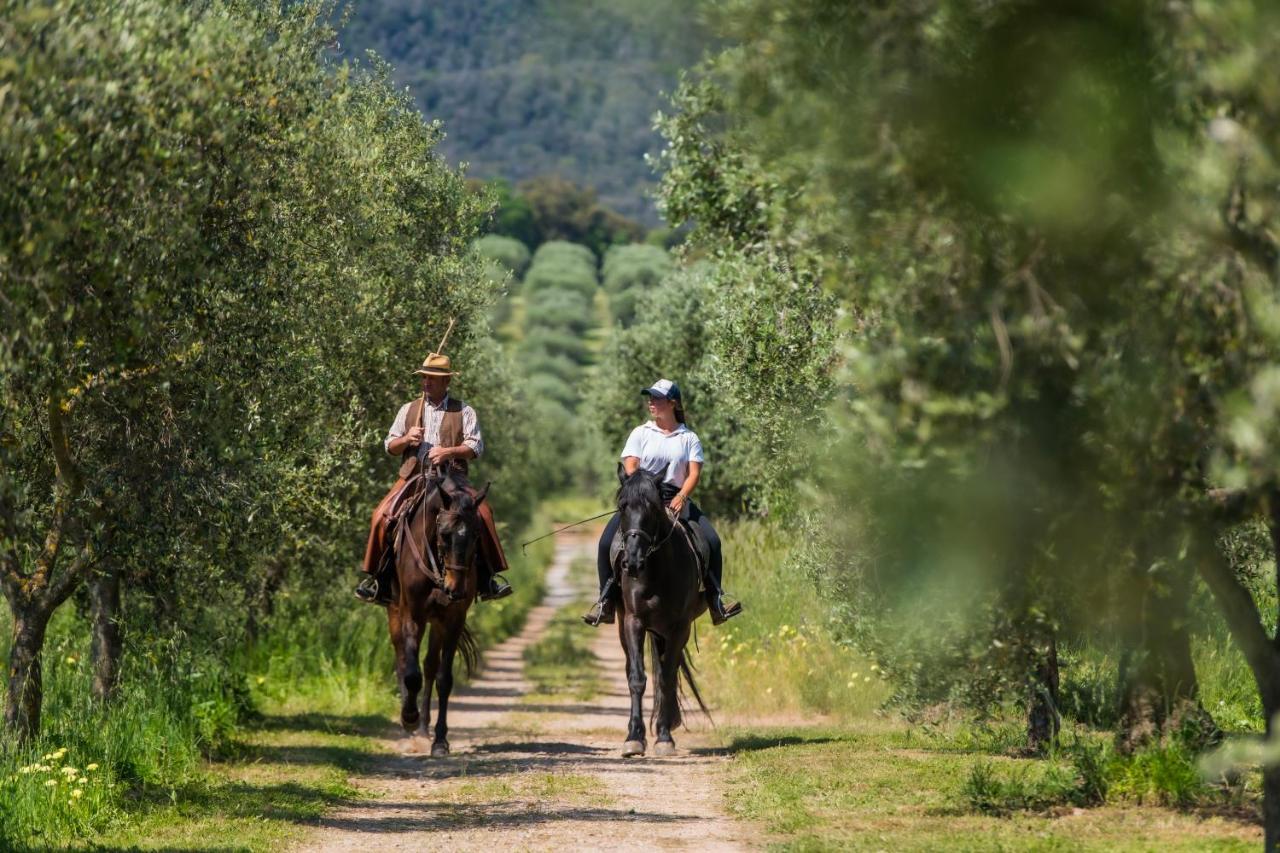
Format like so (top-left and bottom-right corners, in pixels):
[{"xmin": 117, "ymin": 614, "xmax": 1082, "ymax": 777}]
[{"xmin": 0, "ymin": 612, "xmax": 250, "ymax": 849}]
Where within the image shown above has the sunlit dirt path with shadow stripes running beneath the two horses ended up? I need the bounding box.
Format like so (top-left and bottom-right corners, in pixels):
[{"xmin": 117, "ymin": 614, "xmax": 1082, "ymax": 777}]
[{"xmin": 302, "ymin": 527, "xmax": 750, "ymax": 850}]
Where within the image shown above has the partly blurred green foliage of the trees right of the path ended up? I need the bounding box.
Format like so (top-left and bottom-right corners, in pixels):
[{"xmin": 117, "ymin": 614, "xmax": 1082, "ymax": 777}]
[{"xmin": 659, "ymin": 0, "xmax": 1280, "ymax": 742}]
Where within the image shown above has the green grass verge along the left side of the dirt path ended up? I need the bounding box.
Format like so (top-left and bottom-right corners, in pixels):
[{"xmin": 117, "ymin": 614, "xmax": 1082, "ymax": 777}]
[{"xmin": 0, "ymin": 503, "xmax": 562, "ymax": 850}]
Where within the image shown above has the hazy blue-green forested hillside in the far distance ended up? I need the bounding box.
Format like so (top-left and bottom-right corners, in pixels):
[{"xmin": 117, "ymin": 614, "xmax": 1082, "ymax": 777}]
[{"xmin": 342, "ymin": 0, "xmax": 703, "ymax": 225}]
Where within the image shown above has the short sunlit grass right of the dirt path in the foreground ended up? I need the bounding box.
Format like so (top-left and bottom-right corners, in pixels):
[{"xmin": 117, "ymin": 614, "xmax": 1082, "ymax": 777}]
[{"xmin": 721, "ymin": 719, "xmax": 1261, "ymax": 850}]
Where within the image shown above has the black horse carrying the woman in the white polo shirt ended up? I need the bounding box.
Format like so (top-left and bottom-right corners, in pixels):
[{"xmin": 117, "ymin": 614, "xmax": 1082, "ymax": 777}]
[{"xmin": 618, "ymin": 469, "xmax": 707, "ymax": 757}]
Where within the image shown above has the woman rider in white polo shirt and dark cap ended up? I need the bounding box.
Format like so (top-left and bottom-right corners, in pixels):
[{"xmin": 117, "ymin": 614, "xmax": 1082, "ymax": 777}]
[{"xmin": 582, "ymin": 379, "xmax": 742, "ymax": 626}]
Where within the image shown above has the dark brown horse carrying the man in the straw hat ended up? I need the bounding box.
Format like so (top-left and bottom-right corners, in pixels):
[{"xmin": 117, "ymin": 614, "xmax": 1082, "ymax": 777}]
[{"xmin": 387, "ymin": 466, "xmax": 489, "ymax": 757}]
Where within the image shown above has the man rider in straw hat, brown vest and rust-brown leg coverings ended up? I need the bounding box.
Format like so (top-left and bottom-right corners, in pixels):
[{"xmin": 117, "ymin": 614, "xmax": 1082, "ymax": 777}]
[{"xmin": 356, "ymin": 352, "xmax": 511, "ymax": 606}]
